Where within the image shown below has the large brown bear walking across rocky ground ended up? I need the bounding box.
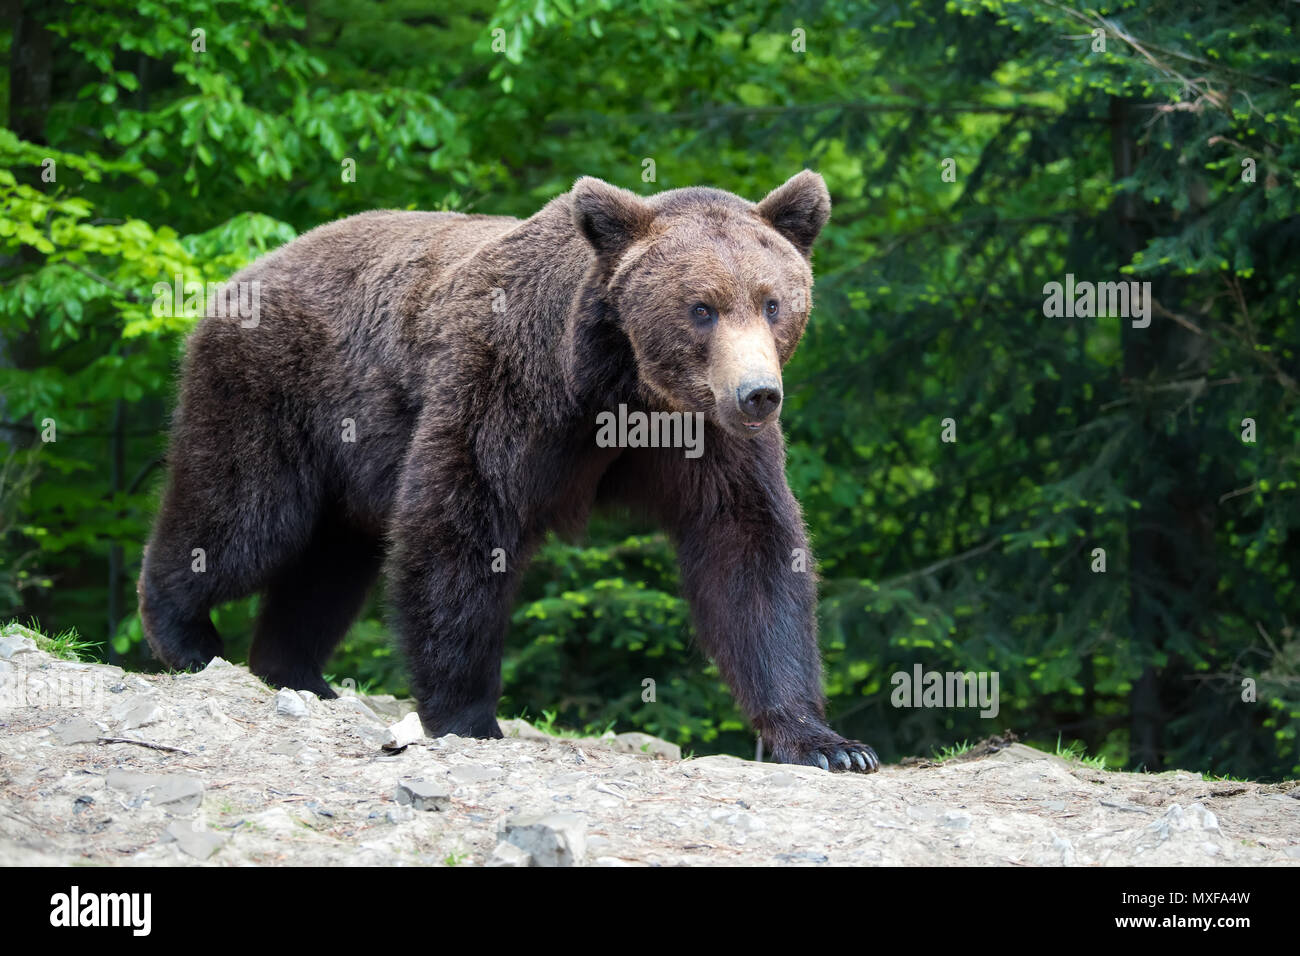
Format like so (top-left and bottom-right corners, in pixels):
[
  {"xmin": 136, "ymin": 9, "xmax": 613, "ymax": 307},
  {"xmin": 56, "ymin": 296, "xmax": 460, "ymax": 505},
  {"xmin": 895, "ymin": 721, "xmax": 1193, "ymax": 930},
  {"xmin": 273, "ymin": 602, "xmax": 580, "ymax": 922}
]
[{"xmin": 139, "ymin": 170, "xmax": 879, "ymax": 773}]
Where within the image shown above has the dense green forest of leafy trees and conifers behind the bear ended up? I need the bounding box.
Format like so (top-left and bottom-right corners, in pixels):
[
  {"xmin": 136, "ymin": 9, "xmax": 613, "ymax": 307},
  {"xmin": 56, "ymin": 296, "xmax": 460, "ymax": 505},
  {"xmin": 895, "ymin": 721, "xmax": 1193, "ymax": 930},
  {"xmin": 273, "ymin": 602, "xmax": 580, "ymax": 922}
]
[{"xmin": 0, "ymin": 0, "xmax": 1300, "ymax": 778}]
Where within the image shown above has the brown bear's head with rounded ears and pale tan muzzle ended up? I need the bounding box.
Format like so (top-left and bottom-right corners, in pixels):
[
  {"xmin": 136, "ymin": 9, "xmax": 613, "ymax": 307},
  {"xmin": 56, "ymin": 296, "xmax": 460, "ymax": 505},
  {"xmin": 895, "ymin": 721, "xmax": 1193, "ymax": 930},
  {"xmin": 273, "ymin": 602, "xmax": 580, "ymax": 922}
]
[{"xmin": 572, "ymin": 170, "xmax": 831, "ymax": 436}]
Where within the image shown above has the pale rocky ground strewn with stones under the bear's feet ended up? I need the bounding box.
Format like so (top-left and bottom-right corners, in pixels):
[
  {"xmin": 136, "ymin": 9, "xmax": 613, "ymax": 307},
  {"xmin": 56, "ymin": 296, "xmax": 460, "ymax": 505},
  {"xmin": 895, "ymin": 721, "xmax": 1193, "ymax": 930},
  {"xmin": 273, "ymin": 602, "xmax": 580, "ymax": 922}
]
[{"xmin": 0, "ymin": 628, "xmax": 1300, "ymax": 866}]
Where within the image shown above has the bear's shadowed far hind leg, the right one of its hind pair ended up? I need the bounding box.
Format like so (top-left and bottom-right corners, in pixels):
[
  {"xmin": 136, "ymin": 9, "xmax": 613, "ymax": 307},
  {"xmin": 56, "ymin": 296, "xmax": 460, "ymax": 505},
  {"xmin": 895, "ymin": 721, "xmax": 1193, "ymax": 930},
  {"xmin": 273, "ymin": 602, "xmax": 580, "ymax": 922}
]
[{"xmin": 248, "ymin": 518, "xmax": 382, "ymax": 698}]
